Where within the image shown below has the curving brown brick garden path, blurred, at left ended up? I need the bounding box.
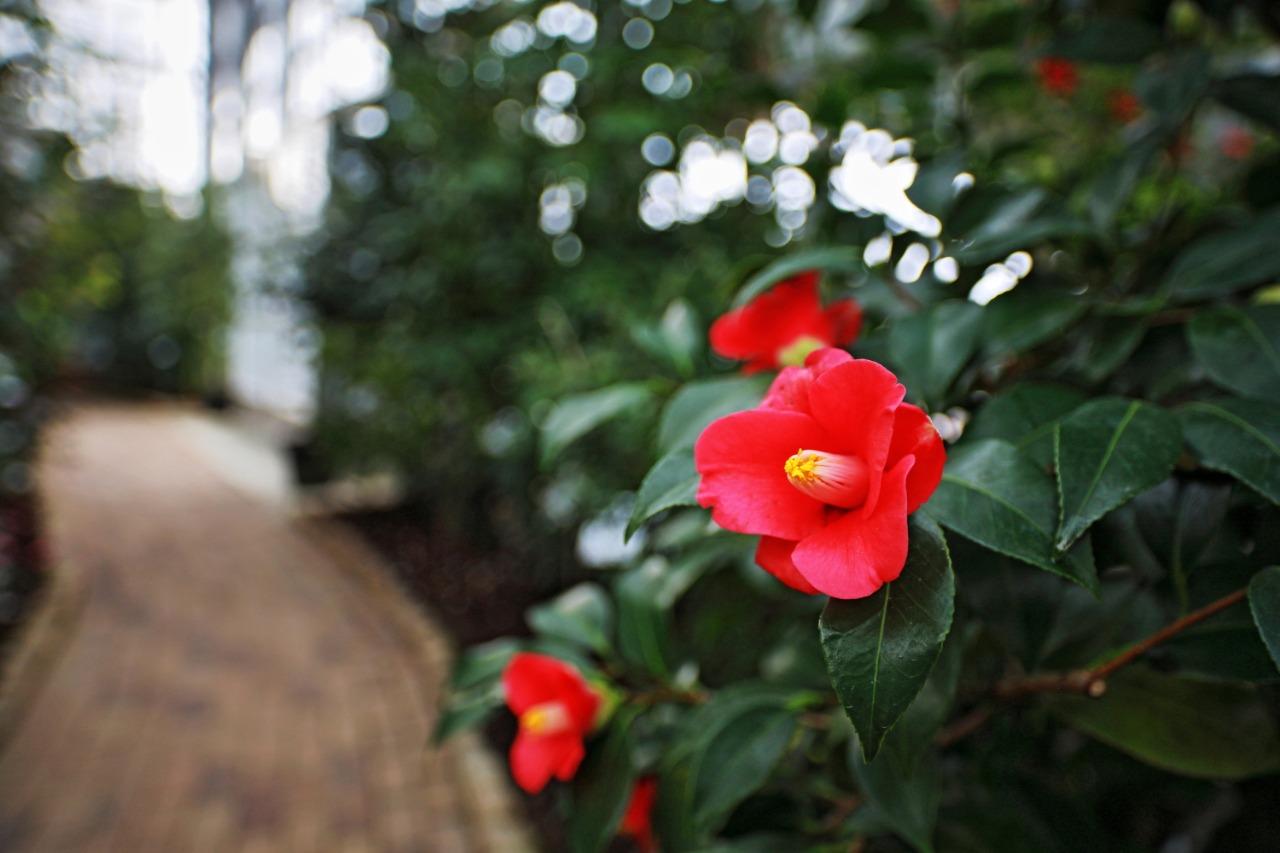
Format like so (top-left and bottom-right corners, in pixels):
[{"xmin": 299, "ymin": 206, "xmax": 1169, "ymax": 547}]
[{"xmin": 0, "ymin": 406, "xmax": 527, "ymax": 853}]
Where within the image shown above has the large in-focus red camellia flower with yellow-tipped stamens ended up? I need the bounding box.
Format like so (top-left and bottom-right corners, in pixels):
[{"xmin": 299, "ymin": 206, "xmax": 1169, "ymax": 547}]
[{"xmin": 694, "ymin": 348, "xmax": 946, "ymax": 598}]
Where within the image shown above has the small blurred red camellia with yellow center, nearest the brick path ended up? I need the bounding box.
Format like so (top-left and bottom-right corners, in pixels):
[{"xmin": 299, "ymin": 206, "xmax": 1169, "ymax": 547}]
[{"xmin": 502, "ymin": 652, "xmax": 600, "ymax": 794}]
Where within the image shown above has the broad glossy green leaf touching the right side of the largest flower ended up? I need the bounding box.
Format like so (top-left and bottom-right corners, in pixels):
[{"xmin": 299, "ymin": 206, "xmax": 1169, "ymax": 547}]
[{"xmin": 925, "ymin": 439, "xmax": 1098, "ymax": 592}]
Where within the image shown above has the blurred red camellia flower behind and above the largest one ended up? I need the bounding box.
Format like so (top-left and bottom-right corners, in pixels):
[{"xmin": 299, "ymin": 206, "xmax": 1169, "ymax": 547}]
[{"xmin": 710, "ymin": 270, "xmax": 863, "ymax": 373}]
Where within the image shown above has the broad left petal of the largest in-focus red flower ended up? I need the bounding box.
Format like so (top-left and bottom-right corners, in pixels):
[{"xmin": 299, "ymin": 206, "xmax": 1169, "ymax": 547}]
[{"xmin": 694, "ymin": 409, "xmax": 827, "ymax": 539}]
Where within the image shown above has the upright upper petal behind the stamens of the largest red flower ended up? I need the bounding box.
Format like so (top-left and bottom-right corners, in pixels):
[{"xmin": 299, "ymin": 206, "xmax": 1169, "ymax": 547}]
[{"xmin": 809, "ymin": 359, "xmax": 906, "ymax": 511}]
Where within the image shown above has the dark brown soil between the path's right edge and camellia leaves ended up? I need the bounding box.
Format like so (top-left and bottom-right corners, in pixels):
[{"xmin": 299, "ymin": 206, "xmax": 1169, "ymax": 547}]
[{"xmin": 344, "ymin": 507, "xmax": 596, "ymax": 850}]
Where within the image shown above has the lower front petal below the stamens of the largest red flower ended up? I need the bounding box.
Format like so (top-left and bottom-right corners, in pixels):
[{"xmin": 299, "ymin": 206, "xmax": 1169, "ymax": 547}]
[{"xmin": 791, "ymin": 457, "xmax": 914, "ymax": 598}]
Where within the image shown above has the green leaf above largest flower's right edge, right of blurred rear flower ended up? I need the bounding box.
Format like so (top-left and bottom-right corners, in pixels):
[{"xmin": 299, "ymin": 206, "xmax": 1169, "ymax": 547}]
[{"xmin": 888, "ymin": 300, "xmax": 982, "ymax": 406}]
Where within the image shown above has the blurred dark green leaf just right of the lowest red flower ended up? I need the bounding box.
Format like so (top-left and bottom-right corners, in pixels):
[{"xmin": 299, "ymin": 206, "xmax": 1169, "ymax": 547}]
[{"xmin": 655, "ymin": 683, "xmax": 797, "ymax": 850}]
